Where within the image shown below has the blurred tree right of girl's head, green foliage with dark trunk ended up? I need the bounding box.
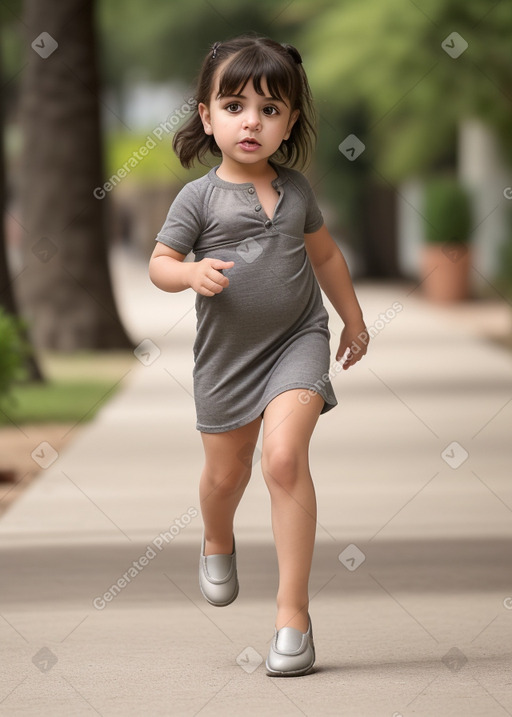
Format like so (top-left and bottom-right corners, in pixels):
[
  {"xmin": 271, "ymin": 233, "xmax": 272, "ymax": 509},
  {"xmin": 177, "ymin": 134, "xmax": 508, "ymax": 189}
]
[{"xmin": 288, "ymin": 0, "xmax": 512, "ymax": 276}]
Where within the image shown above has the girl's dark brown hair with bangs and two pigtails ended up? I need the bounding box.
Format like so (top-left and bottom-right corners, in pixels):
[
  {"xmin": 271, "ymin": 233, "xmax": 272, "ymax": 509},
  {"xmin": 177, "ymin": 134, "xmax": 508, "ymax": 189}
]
[{"xmin": 173, "ymin": 35, "xmax": 316, "ymax": 169}]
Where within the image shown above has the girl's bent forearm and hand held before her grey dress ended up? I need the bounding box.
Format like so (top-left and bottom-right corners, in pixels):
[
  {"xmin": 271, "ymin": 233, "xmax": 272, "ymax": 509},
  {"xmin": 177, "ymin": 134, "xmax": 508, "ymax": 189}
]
[{"xmin": 149, "ymin": 242, "xmax": 234, "ymax": 296}]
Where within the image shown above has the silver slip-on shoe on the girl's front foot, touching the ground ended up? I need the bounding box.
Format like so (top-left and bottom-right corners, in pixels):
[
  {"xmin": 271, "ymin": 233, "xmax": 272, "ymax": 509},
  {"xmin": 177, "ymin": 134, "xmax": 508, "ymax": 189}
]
[{"xmin": 265, "ymin": 615, "xmax": 315, "ymax": 677}]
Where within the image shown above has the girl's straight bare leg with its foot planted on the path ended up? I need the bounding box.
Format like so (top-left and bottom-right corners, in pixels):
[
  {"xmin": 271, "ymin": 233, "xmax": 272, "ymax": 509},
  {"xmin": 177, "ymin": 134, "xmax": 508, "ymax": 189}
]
[{"xmin": 262, "ymin": 389, "xmax": 324, "ymax": 632}]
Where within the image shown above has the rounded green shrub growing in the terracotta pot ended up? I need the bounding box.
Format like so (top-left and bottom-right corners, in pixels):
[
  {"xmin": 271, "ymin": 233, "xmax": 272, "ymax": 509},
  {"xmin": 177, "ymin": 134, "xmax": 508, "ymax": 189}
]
[{"xmin": 423, "ymin": 177, "xmax": 471, "ymax": 244}]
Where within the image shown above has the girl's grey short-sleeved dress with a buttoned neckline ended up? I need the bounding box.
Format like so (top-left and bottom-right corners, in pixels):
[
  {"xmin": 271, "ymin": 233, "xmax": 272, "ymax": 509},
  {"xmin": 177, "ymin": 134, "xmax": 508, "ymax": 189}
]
[{"xmin": 157, "ymin": 164, "xmax": 337, "ymax": 433}]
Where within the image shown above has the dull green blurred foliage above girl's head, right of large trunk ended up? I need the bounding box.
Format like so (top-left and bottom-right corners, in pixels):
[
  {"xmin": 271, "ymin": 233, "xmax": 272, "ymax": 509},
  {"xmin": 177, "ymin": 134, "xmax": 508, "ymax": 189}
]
[{"xmin": 98, "ymin": 0, "xmax": 304, "ymax": 85}]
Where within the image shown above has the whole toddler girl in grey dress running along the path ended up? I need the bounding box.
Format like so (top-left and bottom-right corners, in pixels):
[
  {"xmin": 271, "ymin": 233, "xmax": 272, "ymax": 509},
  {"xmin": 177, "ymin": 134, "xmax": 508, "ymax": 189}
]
[{"xmin": 150, "ymin": 36, "xmax": 368, "ymax": 675}]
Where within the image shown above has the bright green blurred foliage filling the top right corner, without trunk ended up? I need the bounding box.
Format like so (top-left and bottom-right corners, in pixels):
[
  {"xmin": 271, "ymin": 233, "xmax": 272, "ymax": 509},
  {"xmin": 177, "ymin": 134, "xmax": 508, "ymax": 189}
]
[{"xmin": 302, "ymin": 0, "xmax": 512, "ymax": 181}]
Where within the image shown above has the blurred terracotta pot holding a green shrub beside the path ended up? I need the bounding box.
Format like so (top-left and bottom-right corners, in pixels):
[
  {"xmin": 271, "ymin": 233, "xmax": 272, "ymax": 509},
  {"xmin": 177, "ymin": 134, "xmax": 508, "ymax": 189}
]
[{"xmin": 421, "ymin": 244, "xmax": 471, "ymax": 304}]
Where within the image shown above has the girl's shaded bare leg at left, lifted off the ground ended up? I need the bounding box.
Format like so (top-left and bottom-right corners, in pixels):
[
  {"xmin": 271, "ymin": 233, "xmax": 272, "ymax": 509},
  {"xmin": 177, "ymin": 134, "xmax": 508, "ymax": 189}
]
[{"xmin": 199, "ymin": 418, "xmax": 261, "ymax": 555}]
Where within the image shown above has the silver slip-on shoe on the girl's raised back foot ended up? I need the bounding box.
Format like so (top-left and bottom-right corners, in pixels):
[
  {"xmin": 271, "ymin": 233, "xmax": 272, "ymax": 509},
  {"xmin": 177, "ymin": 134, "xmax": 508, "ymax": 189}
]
[{"xmin": 199, "ymin": 533, "xmax": 239, "ymax": 607}]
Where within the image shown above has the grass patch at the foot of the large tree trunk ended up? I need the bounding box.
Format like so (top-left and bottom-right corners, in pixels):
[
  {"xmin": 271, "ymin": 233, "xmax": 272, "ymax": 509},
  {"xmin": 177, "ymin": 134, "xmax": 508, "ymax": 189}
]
[{"xmin": 0, "ymin": 352, "xmax": 134, "ymax": 426}]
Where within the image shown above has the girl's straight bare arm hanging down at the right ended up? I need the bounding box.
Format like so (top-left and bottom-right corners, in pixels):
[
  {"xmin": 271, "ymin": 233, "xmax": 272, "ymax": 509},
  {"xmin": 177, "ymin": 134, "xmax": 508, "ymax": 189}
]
[{"xmin": 304, "ymin": 224, "xmax": 370, "ymax": 369}]
